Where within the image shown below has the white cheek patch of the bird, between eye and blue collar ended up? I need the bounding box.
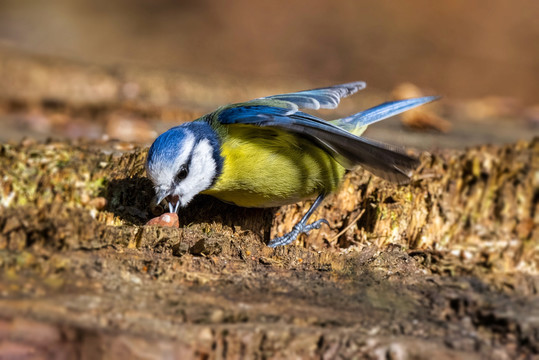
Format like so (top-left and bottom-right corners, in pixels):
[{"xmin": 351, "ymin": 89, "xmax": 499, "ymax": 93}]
[{"xmin": 178, "ymin": 139, "xmax": 217, "ymax": 206}]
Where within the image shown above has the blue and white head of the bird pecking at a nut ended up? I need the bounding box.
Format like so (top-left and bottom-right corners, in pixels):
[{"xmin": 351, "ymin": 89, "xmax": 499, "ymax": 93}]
[{"xmin": 146, "ymin": 122, "xmax": 223, "ymax": 212}]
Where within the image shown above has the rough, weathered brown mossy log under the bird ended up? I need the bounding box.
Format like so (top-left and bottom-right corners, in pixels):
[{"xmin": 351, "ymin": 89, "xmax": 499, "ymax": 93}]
[{"xmin": 0, "ymin": 138, "xmax": 539, "ymax": 359}]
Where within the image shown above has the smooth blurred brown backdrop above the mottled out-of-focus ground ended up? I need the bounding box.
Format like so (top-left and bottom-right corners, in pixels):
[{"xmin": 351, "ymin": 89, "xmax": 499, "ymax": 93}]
[{"xmin": 0, "ymin": 0, "xmax": 539, "ymax": 101}]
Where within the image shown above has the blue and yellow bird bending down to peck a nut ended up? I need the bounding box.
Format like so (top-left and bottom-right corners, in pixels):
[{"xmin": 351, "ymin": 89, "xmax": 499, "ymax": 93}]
[{"xmin": 145, "ymin": 81, "xmax": 438, "ymax": 247}]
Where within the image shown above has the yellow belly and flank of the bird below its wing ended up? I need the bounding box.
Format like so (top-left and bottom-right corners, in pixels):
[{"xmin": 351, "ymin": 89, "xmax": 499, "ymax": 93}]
[{"xmin": 203, "ymin": 125, "xmax": 345, "ymax": 207}]
